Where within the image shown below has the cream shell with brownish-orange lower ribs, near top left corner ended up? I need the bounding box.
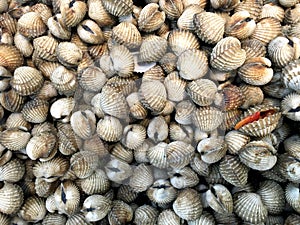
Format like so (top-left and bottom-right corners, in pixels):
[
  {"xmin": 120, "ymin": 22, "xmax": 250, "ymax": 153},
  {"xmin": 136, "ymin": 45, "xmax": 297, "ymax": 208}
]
[{"xmin": 17, "ymin": 12, "xmax": 47, "ymax": 38}]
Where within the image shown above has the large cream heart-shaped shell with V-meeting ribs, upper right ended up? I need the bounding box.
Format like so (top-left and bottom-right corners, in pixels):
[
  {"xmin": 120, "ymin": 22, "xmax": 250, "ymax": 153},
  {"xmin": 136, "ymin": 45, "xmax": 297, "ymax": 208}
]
[{"xmin": 210, "ymin": 37, "xmax": 246, "ymax": 71}]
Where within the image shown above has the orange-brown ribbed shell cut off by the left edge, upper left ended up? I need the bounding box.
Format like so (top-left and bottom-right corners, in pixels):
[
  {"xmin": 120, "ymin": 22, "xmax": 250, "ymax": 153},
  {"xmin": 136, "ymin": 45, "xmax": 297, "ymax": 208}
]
[{"xmin": 0, "ymin": 44, "xmax": 23, "ymax": 71}]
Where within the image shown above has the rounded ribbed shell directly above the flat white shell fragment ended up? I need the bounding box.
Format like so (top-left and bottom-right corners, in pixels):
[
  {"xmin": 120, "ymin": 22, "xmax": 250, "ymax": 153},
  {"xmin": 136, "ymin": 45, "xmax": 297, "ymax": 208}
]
[{"xmin": 140, "ymin": 35, "xmax": 168, "ymax": 62}]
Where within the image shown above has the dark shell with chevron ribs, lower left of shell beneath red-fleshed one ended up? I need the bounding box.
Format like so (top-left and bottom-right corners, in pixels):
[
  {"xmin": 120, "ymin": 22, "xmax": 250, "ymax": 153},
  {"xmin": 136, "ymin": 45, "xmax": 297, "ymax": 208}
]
[{"xmin": 219, "ymin": 155, "xmax": 249, "ymax": 187}]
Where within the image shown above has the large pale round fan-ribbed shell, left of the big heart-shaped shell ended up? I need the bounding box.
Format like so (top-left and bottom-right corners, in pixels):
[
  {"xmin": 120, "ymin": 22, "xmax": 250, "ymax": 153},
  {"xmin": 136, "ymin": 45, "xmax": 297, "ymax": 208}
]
[{"xmin": 177, "ymin": 49, "xmax": 208, "ymax": 80}]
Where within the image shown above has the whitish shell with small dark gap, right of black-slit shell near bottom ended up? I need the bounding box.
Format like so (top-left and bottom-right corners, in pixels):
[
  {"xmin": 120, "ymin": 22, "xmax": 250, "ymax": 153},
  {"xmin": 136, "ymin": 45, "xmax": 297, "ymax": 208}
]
[{"xmin": 81, "ymin": 195, "xmax": 112, "ymax": 222}]
